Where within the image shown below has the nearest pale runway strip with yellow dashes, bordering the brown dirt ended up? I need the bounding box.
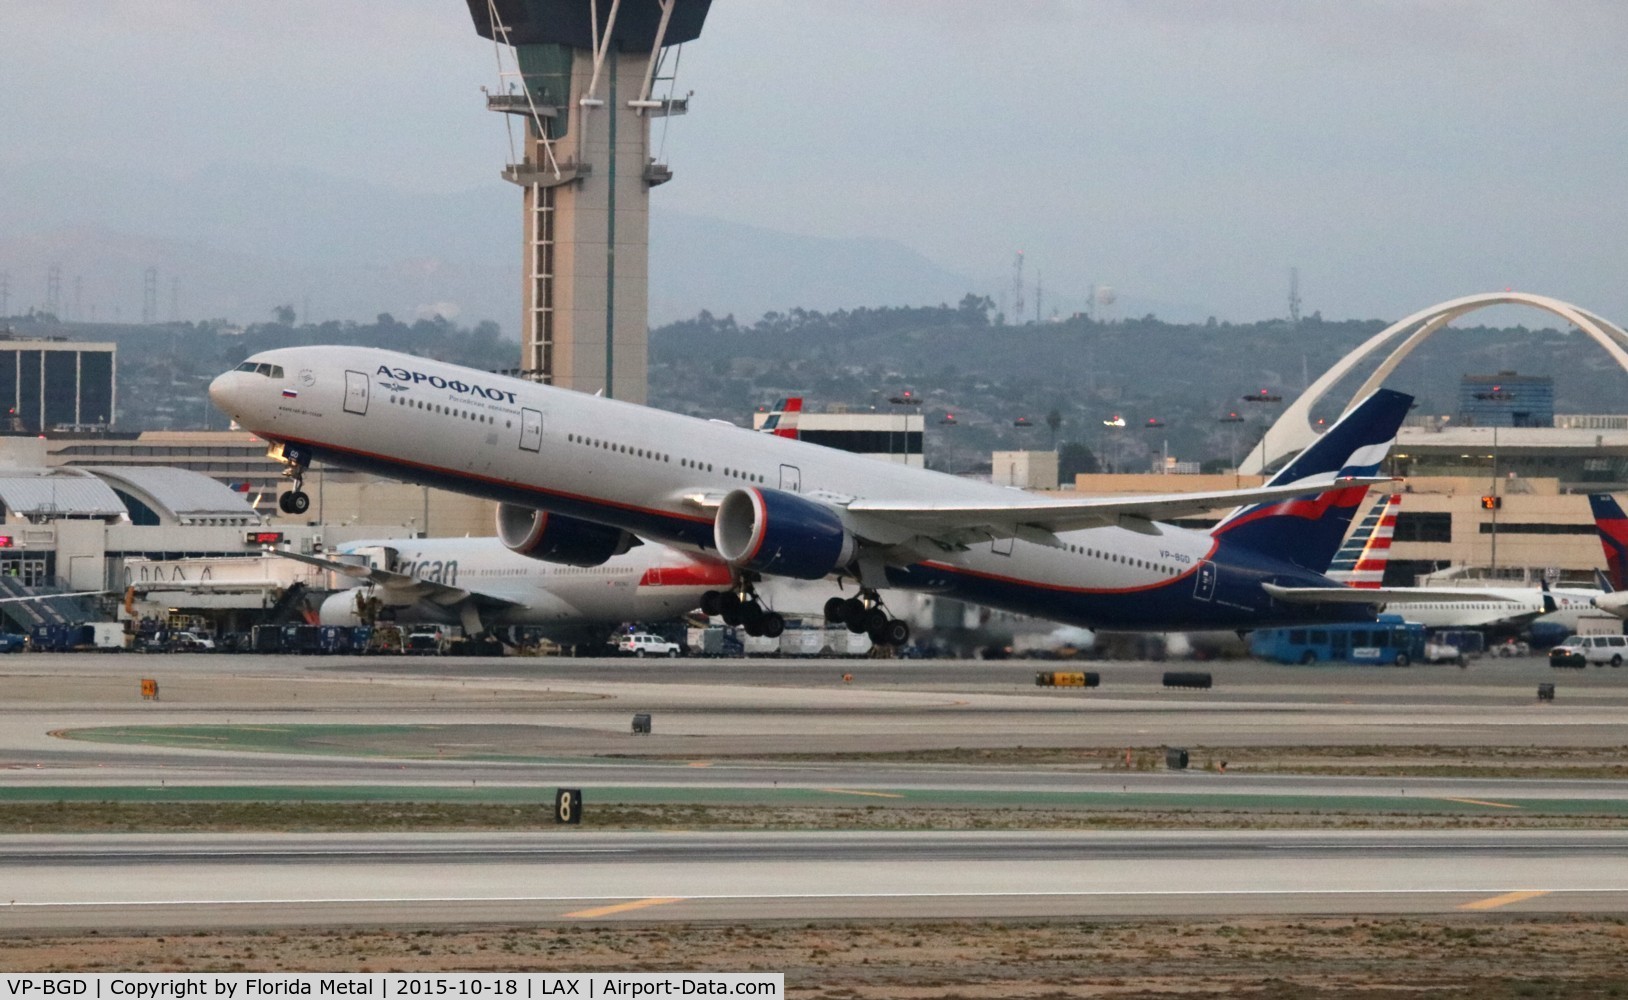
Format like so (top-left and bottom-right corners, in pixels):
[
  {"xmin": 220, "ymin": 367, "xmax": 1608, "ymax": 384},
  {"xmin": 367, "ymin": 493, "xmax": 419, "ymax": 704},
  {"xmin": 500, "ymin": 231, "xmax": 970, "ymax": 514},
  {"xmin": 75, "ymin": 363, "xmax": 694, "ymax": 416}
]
[{"xmin": 0, "ymin": 831, "xmax": 1628, "ymax": 928}]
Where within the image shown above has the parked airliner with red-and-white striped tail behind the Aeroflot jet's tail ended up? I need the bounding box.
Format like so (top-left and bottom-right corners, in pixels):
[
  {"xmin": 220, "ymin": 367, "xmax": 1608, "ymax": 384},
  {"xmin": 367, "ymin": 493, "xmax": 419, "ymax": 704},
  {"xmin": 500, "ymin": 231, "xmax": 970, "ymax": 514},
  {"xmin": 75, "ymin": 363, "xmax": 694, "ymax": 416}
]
[{"xmin": 1275, "ymin": 493, "xmax": 1600, "ymax": 629}]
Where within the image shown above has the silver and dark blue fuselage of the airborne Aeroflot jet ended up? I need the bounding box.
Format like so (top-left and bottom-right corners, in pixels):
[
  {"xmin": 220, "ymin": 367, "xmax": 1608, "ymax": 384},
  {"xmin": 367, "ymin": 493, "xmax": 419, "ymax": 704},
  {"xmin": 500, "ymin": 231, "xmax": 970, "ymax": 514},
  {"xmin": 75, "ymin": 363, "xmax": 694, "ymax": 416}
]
[{"xmin": 210, "ymin": 347, "xmax": 1372, "ymax": 630}]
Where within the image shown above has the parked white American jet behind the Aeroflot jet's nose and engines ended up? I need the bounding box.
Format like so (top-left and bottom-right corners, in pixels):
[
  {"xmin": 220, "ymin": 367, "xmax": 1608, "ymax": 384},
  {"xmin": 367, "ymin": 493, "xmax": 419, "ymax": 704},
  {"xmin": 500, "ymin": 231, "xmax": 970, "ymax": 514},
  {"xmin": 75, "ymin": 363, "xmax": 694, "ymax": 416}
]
[{"xmin": 277, "ymin": 537, "xmax": 734, "ymax": 642}]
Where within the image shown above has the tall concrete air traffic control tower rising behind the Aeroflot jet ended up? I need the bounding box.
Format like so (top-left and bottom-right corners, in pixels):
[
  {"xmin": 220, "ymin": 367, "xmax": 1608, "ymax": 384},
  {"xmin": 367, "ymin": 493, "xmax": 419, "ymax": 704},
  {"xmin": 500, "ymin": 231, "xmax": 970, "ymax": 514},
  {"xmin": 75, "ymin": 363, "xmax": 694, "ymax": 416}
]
[{"xmin": 466, "ymin": 0, "xmax": 711, "ymax": 402}]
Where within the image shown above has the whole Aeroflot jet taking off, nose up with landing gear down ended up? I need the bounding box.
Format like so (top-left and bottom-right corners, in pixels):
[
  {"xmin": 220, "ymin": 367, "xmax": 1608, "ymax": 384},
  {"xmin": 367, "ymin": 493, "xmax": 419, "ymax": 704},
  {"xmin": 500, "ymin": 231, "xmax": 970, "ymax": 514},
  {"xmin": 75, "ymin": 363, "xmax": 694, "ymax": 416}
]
[{"xmin": 210, "ymin": 347, "xmax": 1411, "ymax": 643}]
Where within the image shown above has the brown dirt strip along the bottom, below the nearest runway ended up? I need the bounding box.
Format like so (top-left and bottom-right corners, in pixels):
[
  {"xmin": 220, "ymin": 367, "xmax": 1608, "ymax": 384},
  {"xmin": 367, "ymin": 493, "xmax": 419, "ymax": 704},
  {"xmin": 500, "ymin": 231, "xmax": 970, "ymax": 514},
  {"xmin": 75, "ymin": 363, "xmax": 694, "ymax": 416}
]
[{"xmin": 0, "ymin": 915, "xmax": 1628, "ymax": 1000}]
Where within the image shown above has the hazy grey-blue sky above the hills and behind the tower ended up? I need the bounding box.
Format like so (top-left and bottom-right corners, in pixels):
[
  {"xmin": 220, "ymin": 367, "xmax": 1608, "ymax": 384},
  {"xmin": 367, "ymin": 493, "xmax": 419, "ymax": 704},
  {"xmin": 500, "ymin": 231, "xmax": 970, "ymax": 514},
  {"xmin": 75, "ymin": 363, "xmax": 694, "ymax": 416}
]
[{"xmin": 0, "ymin": 0, "xmax": 1628, "ymax": 322}]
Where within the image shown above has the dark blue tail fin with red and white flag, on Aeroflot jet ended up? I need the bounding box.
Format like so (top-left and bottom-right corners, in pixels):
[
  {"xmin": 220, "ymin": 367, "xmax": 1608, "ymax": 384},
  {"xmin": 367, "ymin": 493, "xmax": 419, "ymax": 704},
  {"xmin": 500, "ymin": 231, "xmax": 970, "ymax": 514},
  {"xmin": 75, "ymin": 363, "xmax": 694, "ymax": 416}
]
[{"xmin": 1210, "ymin": 389, "xmax": 1413, "ymax": 573}]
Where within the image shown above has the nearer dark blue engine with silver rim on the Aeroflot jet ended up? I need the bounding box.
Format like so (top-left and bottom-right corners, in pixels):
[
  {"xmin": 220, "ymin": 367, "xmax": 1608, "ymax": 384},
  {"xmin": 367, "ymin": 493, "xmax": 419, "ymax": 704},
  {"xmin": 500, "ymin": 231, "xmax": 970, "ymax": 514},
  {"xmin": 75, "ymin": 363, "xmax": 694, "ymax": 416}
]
[{"xmin": 713, "ymin": 489, "xmax": 858, "ymax": 580}]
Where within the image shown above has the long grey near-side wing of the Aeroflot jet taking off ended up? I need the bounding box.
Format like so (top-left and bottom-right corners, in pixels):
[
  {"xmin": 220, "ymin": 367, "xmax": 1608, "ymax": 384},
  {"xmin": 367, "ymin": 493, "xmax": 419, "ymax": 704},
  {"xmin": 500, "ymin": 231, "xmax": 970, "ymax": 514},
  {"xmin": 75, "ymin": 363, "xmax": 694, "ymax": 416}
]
[{"xmin": 843, "ymin": 477, "xmax": 1392, "ymax": 544}]
